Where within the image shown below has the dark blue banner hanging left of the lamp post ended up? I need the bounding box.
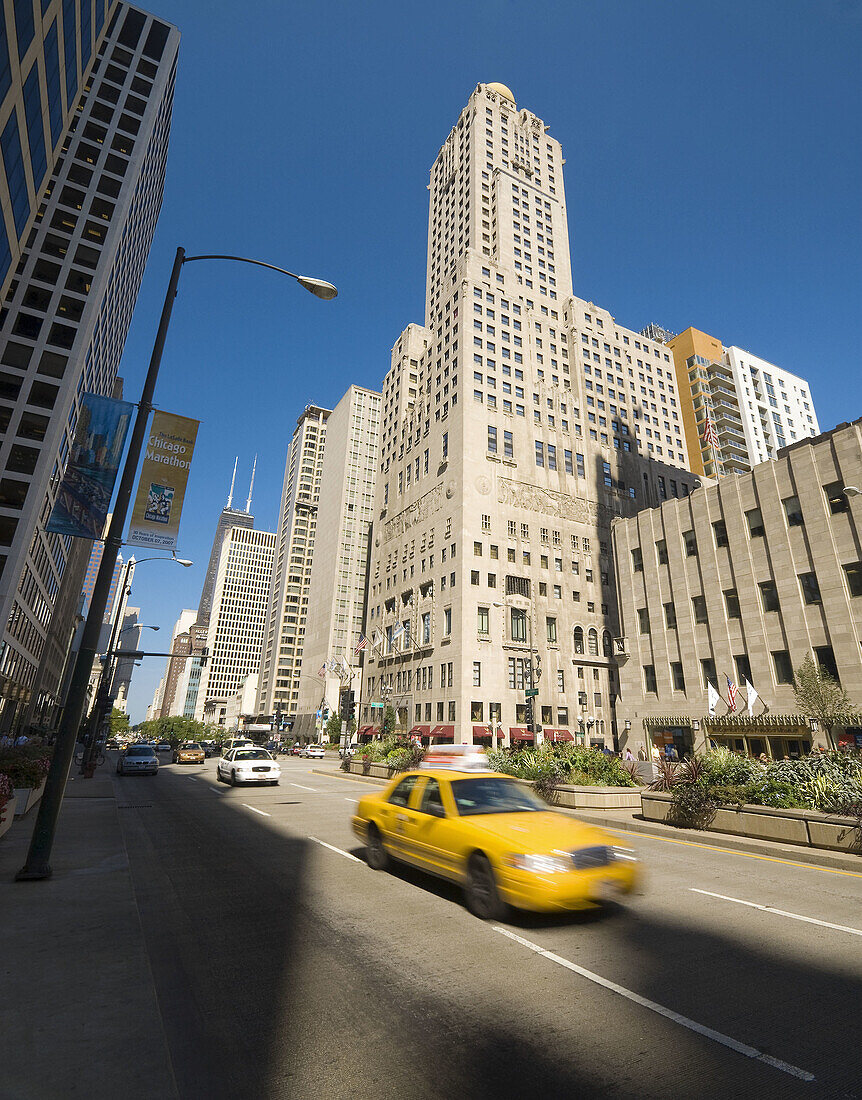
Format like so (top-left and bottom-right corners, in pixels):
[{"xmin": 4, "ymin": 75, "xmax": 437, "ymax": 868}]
[{"xmin": 45, "ymin": 394, "xmax": 134, "ymax": 539}]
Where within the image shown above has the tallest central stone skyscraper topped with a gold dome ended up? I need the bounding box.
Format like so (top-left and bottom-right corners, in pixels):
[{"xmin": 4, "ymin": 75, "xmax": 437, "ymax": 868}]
[{"xmin": 361, "ymin": 84, "xmax": 694, "ymax": 745}]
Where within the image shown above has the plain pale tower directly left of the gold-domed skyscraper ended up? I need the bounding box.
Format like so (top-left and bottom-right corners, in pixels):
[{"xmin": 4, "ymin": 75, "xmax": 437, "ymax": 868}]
[{"xmin": 294, "ymin": 386, "xmax": 380, "ymax": 737}]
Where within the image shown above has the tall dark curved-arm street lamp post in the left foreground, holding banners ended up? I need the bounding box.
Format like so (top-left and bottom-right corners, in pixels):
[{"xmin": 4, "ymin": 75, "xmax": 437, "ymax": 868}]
[{"xmin": 15, "ymin": 248, "xmax": 338, "ymax": 881}]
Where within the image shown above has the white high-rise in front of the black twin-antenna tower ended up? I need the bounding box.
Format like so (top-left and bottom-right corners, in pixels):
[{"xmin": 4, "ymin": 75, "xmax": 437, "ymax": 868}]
[{"xmin": 195, "ymin": 527, "xmax": 275, "ymax": 724}]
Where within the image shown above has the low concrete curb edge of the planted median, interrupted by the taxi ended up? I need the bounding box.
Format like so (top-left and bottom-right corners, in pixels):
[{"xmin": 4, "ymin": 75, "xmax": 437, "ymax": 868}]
[{"xmin": 314, "ymin": 761, "xmax": 862, "ymax": 875}]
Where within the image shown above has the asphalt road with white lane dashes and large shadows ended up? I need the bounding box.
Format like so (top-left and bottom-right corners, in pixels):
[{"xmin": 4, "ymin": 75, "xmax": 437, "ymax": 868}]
[{"xmin": 115, "ymin": 758, "xmax": 862, "ymax": 1100}]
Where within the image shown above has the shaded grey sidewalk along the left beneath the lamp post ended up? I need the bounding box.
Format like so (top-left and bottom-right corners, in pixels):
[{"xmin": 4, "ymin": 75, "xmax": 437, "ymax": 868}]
[{"xmin": 0, "ymin": 774, "xmax": 177, "ymax": 1100}]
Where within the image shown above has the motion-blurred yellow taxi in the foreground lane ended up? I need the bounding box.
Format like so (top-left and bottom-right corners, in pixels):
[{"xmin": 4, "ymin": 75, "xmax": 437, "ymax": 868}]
[{"xmin": 352, "ymin": 765, "xmax": 638, "ymax": 920}]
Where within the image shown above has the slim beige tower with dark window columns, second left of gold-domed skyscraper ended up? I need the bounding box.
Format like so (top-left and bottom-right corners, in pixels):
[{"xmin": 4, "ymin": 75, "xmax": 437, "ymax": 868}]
[{"xmin": 257, "ymin": 405, "xmax": 330, "ymax": 718}]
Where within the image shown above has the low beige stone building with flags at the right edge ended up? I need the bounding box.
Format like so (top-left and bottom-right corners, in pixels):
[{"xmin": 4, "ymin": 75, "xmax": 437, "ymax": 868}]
[{"xmin": 612, "ymin": 420, "xmax": 862, "ymax": 757}]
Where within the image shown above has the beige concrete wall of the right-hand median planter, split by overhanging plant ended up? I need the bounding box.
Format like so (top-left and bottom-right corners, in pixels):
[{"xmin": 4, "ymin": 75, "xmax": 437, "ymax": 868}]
[{"xmin": 641, "ymin": 791, "xmax": 860, "ymax": 853}]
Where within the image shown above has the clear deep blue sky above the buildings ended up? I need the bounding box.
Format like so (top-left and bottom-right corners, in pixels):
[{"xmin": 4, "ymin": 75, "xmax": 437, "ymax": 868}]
[{"xmin": 121, "ymin": 0, "xmax": 862, "ymax": 721}]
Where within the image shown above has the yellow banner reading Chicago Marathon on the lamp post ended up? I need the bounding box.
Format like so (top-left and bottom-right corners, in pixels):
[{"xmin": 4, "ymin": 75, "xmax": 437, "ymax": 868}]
[{"xmin": 125, "ymin": 413, "xmax": 200, "ymax": 550}]
